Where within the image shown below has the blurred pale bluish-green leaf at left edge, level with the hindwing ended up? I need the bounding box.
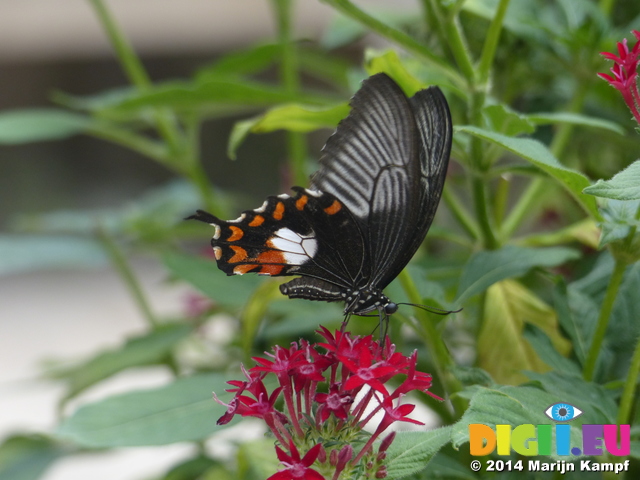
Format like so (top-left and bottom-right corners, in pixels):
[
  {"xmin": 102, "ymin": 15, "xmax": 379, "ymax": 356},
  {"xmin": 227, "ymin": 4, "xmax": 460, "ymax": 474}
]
[{"xmin": 0, "ymin": 235, "xmax": 108, "ymax": 275}]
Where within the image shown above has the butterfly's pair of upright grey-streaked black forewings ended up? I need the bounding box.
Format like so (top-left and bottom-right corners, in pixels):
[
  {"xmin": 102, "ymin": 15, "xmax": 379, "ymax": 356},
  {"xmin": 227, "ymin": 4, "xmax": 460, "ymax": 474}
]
[{"xmin": 312, "ymin": 74, "xmax": 451, "ymax": 289}]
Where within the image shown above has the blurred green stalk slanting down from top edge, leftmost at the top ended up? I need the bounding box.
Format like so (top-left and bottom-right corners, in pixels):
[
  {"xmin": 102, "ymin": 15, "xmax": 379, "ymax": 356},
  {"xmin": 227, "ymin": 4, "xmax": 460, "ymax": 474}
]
[{"xmin": 89, "ymin": 0, "xmax": 181, "ymax": 156}]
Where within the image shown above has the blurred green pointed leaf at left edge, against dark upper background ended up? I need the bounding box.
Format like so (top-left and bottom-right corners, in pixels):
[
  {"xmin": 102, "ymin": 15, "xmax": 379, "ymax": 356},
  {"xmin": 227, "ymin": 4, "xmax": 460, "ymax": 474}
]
[{"xmin": 0, "ymin": 109, "xmax": 91, "ymax": 145}]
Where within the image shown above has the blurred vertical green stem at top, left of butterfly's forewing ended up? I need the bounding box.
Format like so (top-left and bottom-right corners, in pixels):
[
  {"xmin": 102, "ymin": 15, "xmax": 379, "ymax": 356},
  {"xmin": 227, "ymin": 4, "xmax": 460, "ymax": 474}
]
[{"xmin": 272, "ymin": 0, "xmax": 307, "ymax": 185}]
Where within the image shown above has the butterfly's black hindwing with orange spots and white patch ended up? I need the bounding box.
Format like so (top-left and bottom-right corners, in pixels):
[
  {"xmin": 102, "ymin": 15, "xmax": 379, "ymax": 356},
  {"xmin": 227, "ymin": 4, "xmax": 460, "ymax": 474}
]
[{"xmin": 190, "ymin": 187, "xmax": 368, "ymax": 301}]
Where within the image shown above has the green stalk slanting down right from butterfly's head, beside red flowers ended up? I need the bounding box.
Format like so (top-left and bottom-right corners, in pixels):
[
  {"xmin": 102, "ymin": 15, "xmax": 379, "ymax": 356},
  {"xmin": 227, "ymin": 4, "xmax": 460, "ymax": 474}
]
[{"xmin": 398, "ymin": 269, "xmax": 466, "ymax": 415}]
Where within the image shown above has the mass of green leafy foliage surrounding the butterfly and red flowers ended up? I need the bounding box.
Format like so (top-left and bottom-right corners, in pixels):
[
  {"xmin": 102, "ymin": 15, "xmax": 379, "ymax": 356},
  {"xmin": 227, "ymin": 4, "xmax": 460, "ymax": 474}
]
[{"xmin": 0, "ymin": 0, "xmax": 640, "ymax": 480}]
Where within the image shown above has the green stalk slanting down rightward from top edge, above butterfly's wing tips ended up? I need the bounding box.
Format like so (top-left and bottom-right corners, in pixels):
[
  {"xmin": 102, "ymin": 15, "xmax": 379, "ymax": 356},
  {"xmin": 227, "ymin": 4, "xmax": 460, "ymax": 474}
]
[{"xmin": 322, "ymin": 0, "xmax": 467, "ymax": 87}]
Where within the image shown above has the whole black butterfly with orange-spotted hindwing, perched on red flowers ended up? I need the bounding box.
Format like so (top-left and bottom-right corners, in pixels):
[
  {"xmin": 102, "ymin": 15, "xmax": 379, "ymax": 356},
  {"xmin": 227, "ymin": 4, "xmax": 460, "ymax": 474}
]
[{"xmin": 189, "ymin": 73, "xmax": 452, "ymax": 319}]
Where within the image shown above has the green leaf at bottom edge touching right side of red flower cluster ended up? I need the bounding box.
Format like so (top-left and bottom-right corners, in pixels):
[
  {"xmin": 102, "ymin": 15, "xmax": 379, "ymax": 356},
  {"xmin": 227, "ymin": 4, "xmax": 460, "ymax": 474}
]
[{"xmin": 386, "ymin": 427, "xmax": 451, "ymax": 478}]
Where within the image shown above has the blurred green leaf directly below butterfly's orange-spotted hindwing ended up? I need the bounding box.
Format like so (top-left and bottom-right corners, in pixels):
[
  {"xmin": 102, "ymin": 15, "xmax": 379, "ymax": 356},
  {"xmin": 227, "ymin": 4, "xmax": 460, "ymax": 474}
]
[{"xmin": 162, "ymin": 252, "xmax": 261, "ymax": 309}]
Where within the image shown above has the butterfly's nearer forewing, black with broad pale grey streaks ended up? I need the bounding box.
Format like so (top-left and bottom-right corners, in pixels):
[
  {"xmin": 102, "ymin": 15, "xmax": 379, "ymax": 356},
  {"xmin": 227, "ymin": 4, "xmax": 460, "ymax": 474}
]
[{"xmin": 312, "ymin": 74, "xmax": 424, "ymax": 288}]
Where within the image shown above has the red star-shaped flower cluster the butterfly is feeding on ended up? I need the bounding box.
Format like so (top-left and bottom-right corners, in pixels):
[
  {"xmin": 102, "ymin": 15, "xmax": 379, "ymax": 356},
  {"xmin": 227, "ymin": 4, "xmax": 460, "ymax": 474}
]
[{"xmin": 214, "ymin": 327, "xmax": 442, "ymax": 480}]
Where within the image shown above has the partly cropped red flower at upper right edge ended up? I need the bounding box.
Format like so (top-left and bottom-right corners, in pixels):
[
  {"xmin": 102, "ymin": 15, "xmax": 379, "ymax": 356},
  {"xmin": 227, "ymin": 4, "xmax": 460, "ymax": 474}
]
[{"xmin": 598, "ymin": 30, "xmax": 640, "ymax": 124}]
